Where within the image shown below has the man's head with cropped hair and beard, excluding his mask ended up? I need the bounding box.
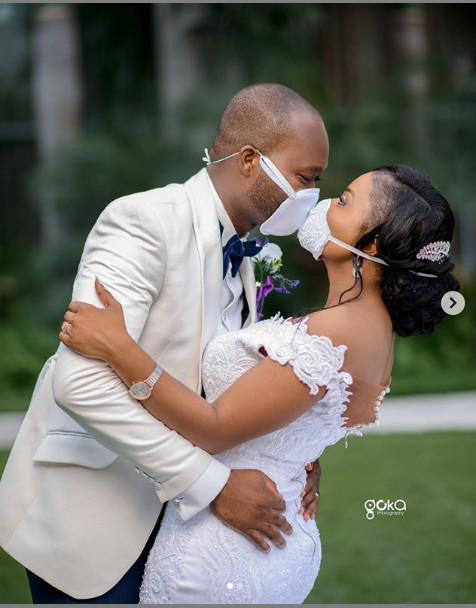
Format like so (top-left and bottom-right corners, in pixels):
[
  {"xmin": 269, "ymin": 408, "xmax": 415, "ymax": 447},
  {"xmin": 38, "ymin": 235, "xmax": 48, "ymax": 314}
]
[{"xmin": 207, "ymin": 84, "xmax": 329, "ymax": 235}]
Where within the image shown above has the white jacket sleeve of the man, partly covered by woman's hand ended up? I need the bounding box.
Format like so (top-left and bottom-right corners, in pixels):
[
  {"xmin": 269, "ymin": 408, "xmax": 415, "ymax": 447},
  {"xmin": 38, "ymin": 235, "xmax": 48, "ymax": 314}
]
[{"xmin": 53, "ymin": 195, "xmax": 229, "ymax": 519}]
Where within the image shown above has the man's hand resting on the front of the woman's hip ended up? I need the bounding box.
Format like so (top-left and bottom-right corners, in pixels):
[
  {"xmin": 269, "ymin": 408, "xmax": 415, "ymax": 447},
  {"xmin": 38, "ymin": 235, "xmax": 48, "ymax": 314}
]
[{"xmin": 211, "ymin": 469, "xmax": 293, "ymax": 553}]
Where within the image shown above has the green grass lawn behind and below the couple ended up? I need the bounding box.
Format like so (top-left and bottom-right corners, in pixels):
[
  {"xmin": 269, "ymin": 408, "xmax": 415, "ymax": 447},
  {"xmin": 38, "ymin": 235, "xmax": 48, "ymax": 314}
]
[{"xmin": 0, "ymin": 432, "xmax": 476, "ymax": 604}]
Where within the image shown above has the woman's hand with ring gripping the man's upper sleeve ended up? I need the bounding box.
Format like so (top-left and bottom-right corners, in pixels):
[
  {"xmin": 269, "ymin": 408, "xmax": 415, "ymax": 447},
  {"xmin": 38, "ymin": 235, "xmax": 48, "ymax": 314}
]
[{"xmin": 59, "ymin": 277, "xmax": 130, "ymax": 361}]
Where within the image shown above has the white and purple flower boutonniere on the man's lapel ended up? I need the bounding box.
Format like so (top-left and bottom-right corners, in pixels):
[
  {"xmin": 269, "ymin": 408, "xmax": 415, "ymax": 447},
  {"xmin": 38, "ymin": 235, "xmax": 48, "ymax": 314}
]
[{"xmin": 252, "ymin": 239, "xmax": 299, "ymax": 321}]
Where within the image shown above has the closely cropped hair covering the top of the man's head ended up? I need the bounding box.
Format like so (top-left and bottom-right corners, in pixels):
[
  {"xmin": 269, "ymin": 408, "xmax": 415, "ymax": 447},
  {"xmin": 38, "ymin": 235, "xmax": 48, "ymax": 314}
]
[{"xmin": 210, "ymin": 83, "xmax": 322, "ymax": 160}]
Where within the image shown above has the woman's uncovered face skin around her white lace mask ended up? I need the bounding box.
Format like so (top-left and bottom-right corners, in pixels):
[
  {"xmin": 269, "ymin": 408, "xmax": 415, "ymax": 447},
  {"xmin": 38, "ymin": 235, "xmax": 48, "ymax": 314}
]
[{"xmin": 322, "ymin": 173, "xmax": 372, "ymax": 261}]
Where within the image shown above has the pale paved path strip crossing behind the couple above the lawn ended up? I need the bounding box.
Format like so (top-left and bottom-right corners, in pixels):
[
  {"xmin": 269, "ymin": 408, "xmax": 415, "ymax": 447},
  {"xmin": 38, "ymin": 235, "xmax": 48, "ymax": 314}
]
[{"xmin": 0, "ymin": 392, "xmax": 476, "ymax": 450}]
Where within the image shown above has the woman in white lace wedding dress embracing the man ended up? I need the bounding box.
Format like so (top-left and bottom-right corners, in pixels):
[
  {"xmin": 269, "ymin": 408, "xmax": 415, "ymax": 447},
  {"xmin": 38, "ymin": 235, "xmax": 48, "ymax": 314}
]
[{"xmin": 60, "ymin": 166, "xmax": 459, "ymax": 604}]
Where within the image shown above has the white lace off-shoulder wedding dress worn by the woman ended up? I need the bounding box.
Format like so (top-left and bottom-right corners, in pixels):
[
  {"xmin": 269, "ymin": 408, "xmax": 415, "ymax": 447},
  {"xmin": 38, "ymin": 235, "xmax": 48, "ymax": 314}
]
[{"xmin": 140, "ymin": 315, "xmax": 386, "ymax": 604}]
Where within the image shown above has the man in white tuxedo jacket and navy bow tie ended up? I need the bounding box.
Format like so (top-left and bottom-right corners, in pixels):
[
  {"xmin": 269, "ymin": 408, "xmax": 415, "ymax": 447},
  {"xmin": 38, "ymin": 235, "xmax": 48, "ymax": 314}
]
[{"xmin": 0, "ymin": 84, "xmax": 328, "ymax": 603}]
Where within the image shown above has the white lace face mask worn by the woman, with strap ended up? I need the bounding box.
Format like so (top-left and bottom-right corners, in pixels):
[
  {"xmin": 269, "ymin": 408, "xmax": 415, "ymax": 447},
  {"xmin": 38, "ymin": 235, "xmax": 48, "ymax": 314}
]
[{"xmin": 298, "ymin": 198, "xmax": 438, "ymax": 279}]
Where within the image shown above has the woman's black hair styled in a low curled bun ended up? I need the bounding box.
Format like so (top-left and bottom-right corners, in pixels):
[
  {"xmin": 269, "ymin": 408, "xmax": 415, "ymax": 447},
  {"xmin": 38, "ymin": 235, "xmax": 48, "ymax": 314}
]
[{"xmin": 352, "ymin": 165, "xmax": 460, "ymax": 337}]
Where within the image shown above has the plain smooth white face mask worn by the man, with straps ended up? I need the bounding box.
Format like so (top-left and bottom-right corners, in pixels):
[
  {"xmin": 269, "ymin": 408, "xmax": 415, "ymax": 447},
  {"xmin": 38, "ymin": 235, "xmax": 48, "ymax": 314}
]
[{"xmin": 202, "ymin": 148, "xmax": 320, "ymax": 236}]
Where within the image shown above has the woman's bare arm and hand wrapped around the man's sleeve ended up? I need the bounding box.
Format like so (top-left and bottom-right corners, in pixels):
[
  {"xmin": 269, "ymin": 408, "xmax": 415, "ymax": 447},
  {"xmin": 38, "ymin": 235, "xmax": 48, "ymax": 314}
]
[{"xmin": 60, "ymin": 282, "xmax": 326, "ymax": 454}]
